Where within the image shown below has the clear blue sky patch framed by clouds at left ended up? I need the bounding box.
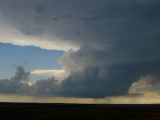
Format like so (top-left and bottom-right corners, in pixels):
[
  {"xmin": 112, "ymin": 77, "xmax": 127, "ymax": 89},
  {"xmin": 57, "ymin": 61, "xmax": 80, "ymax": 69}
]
[{"xmin": 0, "ymin": 43, "xmax": 63, "ymax": 78}]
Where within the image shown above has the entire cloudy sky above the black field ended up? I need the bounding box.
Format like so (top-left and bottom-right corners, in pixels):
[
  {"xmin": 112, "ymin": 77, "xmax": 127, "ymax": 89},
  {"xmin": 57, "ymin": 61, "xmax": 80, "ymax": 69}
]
[{"xmin": 0, "ymin": 0, "xmax": 160, "ymax": 103}]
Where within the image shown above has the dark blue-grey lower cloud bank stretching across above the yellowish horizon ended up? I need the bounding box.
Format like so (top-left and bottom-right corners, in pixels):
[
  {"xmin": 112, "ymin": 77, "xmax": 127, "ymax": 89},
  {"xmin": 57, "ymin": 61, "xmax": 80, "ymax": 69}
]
[{"xmin": 0, "ymin": 61, "xmax": 160, "ymax": 98}]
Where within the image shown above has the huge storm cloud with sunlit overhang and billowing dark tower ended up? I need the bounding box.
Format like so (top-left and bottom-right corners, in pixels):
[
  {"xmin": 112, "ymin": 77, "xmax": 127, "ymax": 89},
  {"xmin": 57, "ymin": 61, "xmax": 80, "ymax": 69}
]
[{"xmin": 0, "ymin": 0, "xmax": 160, "ymax": 97}]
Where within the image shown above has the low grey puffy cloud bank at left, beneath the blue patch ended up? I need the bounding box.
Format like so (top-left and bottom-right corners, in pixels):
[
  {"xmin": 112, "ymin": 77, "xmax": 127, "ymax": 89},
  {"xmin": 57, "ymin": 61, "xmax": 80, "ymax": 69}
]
[{"xmin": 0, "ymin": 66, "xmax": 58, "ymax": 96}]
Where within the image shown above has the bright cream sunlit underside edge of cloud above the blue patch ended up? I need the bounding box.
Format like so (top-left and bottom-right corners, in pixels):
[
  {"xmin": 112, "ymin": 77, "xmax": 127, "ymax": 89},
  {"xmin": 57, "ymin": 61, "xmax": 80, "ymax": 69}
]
[{"xmin": 0, "ymin": 20, "xmax": 79, "ymax": 51}]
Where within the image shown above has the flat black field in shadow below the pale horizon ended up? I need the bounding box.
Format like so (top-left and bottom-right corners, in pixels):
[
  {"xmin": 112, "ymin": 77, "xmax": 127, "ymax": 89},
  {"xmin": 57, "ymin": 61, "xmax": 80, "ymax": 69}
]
[{"xmin": 0, "ymin": 103, "xmax": 160, "ymax": 120}]
